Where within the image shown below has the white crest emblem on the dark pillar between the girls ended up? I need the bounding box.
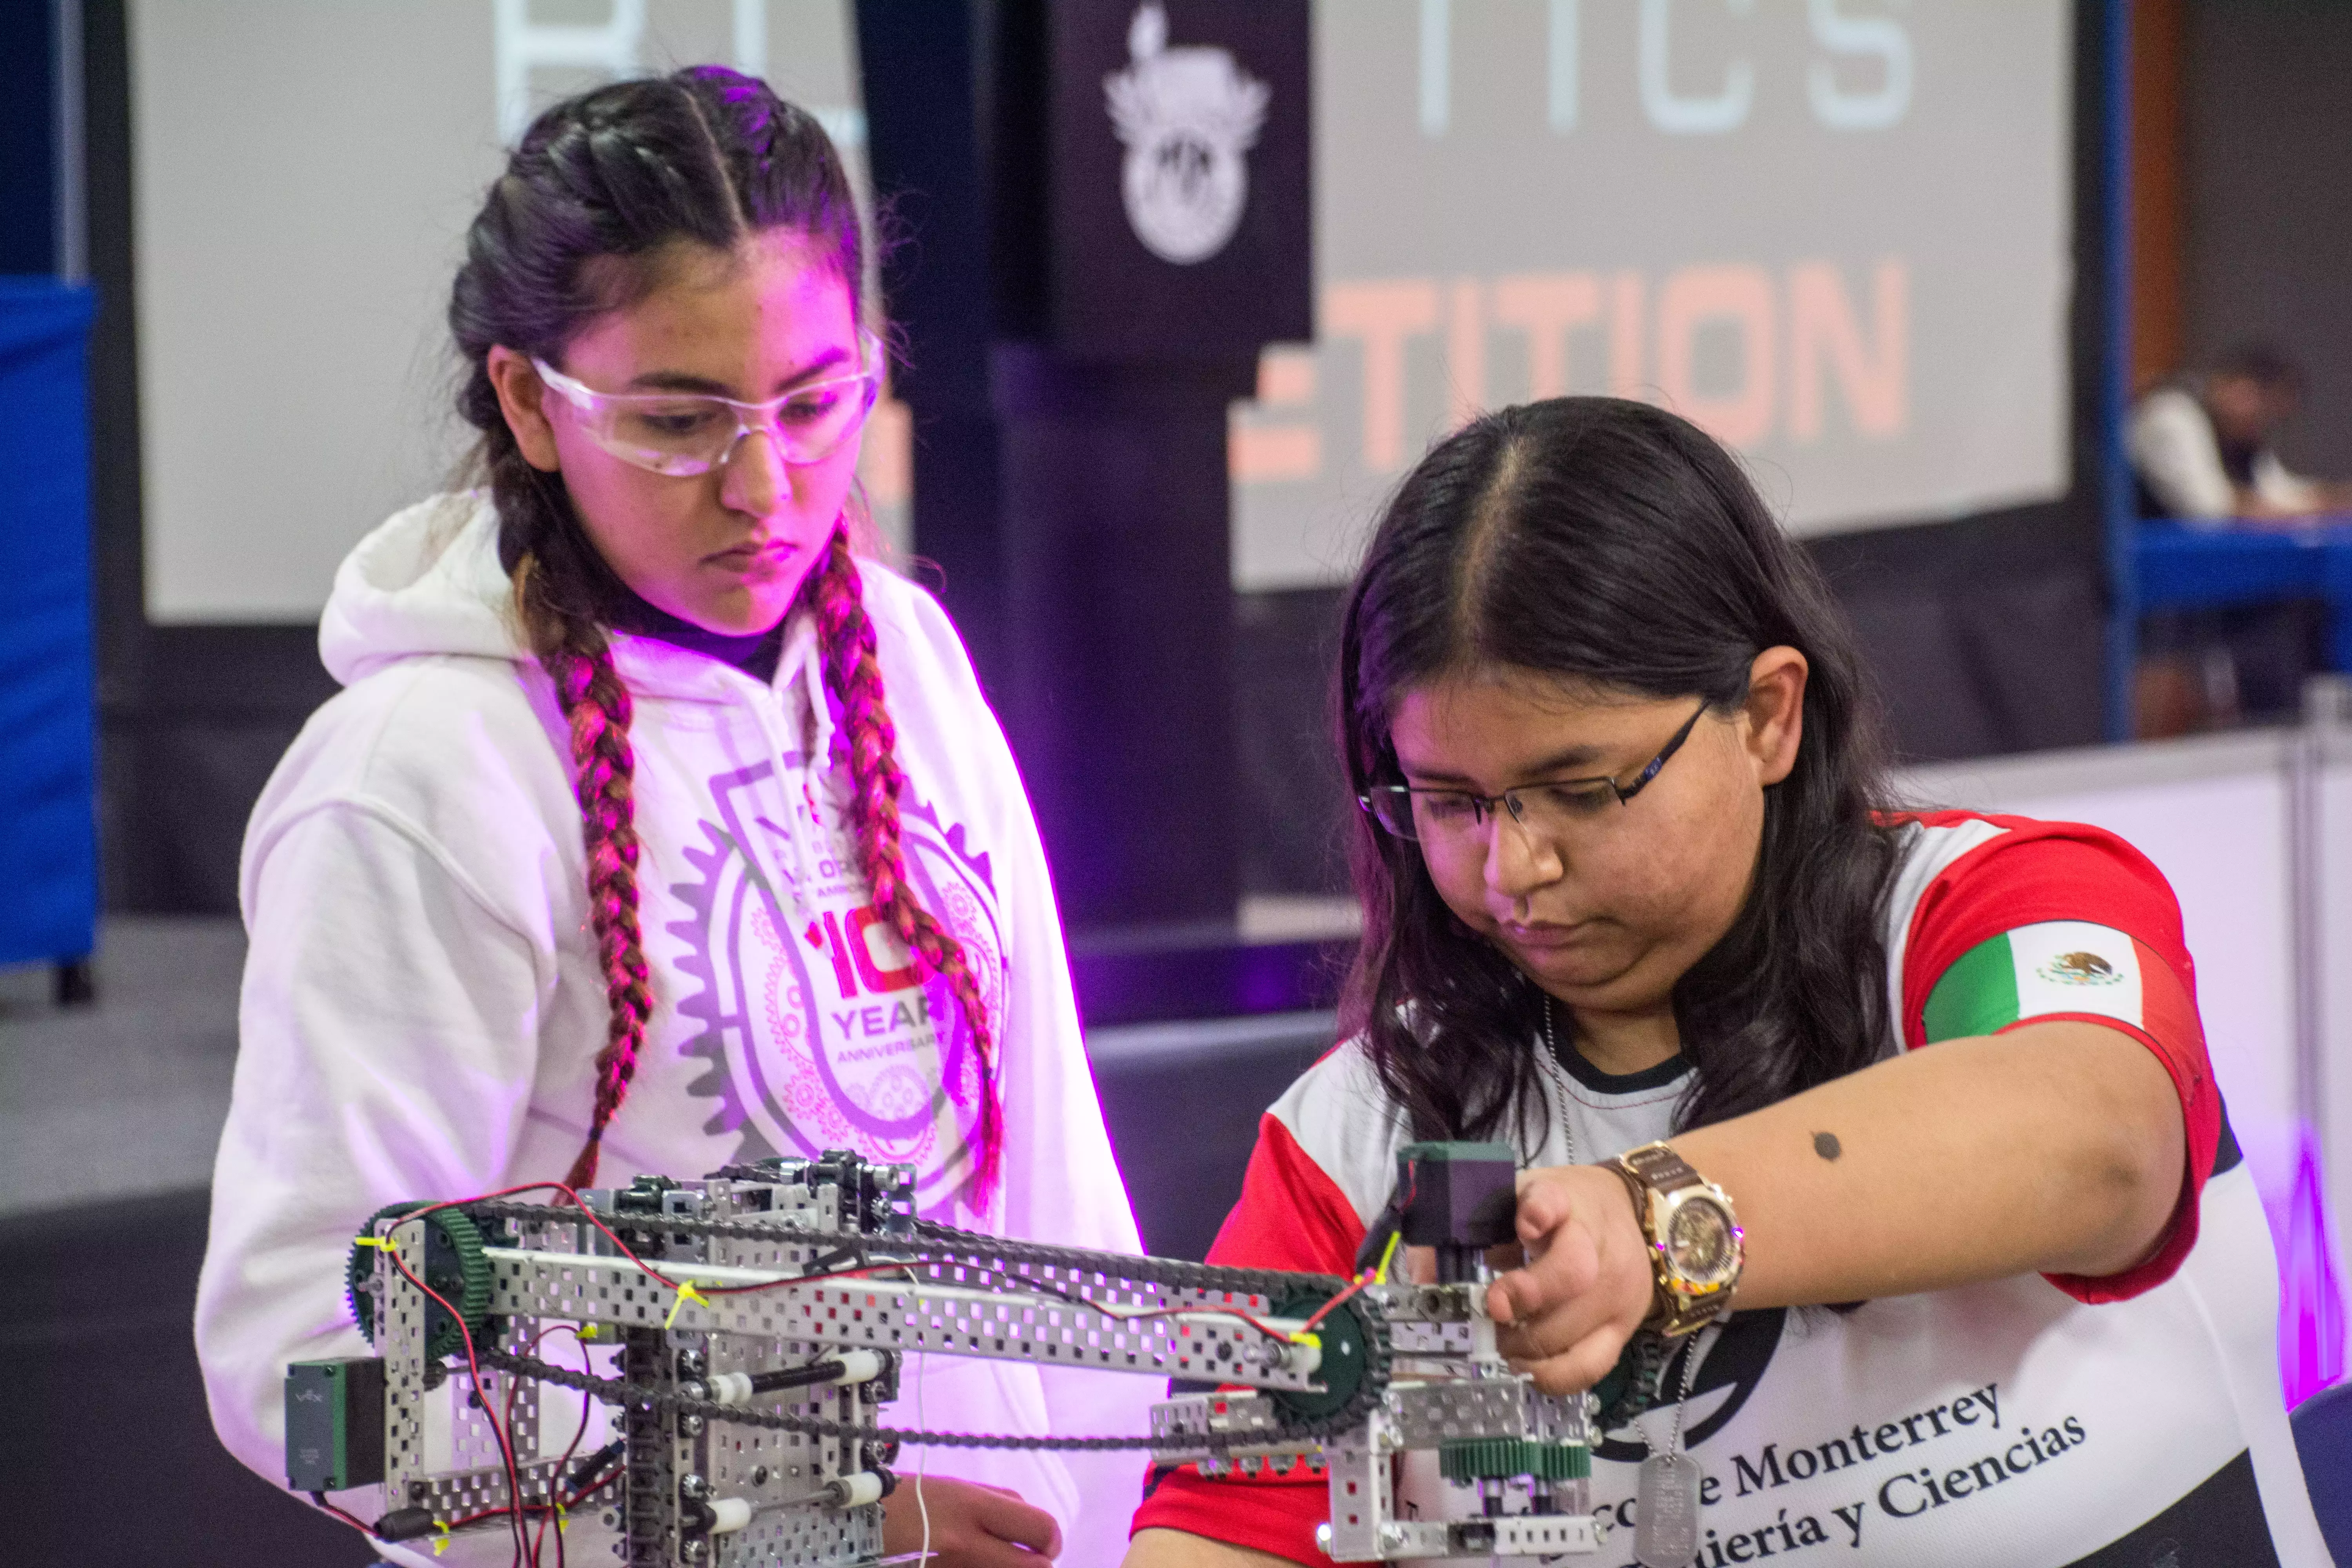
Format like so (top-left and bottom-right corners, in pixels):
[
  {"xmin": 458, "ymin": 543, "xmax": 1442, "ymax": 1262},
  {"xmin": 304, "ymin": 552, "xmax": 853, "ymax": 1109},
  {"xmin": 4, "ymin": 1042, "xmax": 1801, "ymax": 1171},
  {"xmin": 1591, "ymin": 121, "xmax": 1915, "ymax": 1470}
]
[{"xmin": 1103, "ymin": 0, "xmax": 1272, "ymax": 266}]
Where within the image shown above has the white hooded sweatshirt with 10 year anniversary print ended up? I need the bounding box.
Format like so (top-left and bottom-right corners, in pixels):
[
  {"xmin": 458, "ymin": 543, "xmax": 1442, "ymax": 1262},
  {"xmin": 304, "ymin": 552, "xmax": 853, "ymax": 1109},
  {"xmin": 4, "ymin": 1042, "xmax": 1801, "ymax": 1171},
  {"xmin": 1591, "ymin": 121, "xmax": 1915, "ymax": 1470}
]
[{"xmin": 195, "ymin": 496, "xmax": 1157, "ymax": 1568}]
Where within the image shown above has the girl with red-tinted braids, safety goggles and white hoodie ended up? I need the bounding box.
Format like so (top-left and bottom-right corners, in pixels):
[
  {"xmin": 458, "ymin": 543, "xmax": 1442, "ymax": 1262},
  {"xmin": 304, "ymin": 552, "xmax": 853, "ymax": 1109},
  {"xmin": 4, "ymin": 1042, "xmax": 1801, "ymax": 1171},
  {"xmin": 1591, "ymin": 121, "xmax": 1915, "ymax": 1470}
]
[{"xmin": 198, "ymin": 68, "xmax": 1152, "ymax": 1568}]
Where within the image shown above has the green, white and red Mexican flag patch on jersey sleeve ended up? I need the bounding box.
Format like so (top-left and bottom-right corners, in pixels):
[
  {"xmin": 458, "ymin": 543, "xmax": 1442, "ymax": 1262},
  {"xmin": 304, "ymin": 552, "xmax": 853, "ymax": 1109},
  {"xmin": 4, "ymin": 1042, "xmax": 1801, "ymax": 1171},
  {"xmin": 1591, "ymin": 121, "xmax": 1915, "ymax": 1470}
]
[{"xmin": 1922, "ymin": 919, "xmax": 2159, "ymax": 1044}]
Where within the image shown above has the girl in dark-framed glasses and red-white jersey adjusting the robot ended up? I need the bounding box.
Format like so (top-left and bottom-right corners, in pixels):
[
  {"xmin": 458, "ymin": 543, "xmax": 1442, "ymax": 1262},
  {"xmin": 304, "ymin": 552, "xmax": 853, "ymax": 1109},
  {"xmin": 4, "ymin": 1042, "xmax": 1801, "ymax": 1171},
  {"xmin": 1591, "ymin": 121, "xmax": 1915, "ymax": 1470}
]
[{"xmin": 1127, "ymin": 397, "xmax": 2328, "ymax": 1568}]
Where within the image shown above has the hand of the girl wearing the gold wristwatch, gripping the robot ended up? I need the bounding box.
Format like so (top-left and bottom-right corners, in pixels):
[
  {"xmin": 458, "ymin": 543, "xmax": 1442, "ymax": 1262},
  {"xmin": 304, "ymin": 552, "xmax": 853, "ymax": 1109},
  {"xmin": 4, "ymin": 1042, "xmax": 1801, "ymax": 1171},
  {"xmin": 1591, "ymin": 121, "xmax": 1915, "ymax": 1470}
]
[{"xmin": 1486, "ymin": 1166, "xmax": 1658, "ymax": 1394}]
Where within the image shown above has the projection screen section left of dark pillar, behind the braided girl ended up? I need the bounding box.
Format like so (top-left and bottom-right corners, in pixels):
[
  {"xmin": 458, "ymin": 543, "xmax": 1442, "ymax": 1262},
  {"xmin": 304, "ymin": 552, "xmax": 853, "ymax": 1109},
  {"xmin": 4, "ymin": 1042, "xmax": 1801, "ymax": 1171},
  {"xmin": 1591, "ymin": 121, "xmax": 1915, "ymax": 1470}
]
[{"xmin": 129, "ymin": 0, "xmax": 870, "ymax": 623}]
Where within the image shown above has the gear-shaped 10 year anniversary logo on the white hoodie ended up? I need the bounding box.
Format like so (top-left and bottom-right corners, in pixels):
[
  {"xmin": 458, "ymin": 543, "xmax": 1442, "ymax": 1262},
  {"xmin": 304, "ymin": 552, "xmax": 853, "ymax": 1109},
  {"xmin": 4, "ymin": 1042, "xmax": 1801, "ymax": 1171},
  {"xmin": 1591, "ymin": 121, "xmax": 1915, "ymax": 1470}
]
[{"xmin": 668, "ymin": 764, "xmax": 1004, "ymax": 1225}]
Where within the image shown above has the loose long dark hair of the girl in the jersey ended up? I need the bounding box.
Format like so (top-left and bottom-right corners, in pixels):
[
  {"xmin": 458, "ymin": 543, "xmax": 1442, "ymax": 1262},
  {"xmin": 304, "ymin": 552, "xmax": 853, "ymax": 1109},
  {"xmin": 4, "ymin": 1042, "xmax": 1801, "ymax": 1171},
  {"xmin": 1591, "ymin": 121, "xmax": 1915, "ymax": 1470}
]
[{"xmin": 1338, "ymin": 397, "xmax": 1893, "ymax": 1145}]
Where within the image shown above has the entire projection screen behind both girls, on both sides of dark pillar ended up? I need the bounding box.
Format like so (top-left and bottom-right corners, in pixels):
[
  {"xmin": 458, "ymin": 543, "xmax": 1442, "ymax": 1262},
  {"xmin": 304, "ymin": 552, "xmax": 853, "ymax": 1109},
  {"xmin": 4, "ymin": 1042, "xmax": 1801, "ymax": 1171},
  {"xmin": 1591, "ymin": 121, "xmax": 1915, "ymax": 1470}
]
[{"xmin": 129, "ymin": 0, "xmax": 2072, "ymax": 623}]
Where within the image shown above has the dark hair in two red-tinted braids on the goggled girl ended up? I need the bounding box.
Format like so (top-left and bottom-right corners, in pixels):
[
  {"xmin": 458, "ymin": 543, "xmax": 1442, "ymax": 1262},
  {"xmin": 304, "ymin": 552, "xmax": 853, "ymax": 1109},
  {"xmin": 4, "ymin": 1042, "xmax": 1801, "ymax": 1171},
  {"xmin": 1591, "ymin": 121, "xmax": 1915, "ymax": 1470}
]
[{"xmin": 449, "ymin": 66, "xmax": 1002, "ymax": 1203}]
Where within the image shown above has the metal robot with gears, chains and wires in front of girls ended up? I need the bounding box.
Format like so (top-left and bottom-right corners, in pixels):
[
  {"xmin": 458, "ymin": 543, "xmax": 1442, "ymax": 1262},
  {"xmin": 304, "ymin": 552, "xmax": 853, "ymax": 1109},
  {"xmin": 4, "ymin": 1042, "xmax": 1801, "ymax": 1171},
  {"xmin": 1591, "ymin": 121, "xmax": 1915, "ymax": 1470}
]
[{"xmin": 287, "ymin": 1145, "xmax": 1595, "ymax": 1568}]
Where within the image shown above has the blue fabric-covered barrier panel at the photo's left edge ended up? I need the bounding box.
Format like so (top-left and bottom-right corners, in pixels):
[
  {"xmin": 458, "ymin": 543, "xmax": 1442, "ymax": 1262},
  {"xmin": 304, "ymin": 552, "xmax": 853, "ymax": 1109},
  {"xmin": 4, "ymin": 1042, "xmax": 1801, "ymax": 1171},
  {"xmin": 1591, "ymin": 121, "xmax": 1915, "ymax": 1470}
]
[{"xmin": 0, "ymin": 278, "xmax": 99, "ymax": 964}]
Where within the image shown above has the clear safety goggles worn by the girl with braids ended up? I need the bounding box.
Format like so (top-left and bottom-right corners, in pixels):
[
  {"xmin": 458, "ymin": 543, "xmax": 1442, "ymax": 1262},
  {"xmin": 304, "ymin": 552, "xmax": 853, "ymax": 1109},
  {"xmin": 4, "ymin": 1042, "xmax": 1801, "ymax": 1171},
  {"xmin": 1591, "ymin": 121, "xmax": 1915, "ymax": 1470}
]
[{"xmin": 532, "ymin": 334, "xmax": 882, "ymax": 475}]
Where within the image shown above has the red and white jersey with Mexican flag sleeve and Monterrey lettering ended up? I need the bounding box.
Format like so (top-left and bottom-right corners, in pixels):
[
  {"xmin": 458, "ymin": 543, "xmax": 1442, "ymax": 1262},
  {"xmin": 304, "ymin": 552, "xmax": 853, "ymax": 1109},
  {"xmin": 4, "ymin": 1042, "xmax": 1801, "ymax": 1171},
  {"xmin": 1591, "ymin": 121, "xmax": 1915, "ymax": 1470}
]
[{"xmin": 1136, "ymin": 811, "xmax": 2328, "ymax": 1568}]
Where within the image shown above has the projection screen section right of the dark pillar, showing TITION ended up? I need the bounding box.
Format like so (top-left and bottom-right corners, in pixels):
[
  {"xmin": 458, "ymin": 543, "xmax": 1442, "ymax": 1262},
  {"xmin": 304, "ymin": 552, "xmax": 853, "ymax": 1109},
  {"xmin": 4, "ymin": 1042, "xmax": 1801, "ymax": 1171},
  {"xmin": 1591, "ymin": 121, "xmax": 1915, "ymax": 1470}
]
[{"xmin": 1235, "ymin": 0, "xmax": 2072, "ymax": 588}]
